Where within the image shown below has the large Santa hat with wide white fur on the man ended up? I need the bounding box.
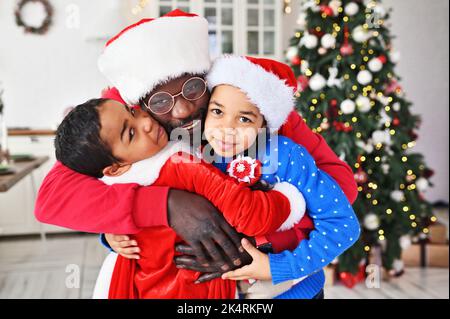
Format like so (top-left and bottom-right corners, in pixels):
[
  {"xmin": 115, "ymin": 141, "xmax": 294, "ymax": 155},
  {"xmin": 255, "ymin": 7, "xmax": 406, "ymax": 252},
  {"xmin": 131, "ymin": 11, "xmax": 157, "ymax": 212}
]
[{"xmin": 98, "ymin": 10, "xmax": 211, "ymax": 104}]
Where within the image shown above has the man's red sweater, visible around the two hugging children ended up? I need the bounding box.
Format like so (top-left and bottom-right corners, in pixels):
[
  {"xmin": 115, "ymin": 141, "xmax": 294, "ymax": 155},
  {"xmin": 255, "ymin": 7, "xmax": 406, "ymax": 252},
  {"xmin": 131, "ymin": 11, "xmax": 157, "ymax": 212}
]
[{"xmin": 34, "ymin": 88, "xmax": 357, "ymax": 251}]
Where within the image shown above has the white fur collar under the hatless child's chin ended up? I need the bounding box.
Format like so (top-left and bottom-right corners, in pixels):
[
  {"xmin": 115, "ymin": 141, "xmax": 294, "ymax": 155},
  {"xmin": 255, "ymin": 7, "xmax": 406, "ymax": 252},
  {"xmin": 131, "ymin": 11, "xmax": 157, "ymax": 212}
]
[{"xmin": 100, "ymin": 142, "xmax": 191, "ymax": 186}]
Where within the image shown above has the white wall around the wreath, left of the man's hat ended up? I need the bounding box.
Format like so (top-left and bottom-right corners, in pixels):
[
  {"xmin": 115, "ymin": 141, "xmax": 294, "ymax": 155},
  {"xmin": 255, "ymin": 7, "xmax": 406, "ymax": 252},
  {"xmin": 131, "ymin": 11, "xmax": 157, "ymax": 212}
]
[{"xmin": 0, "ymin": 0, "xmax": 124, "ymax": 128}]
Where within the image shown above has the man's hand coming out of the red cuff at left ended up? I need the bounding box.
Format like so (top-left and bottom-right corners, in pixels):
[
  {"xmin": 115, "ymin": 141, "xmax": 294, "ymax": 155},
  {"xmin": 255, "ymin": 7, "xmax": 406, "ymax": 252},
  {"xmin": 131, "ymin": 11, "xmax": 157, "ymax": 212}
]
[{"xmin": 168, "ymin": 189, "xmax": 246, "ymax": 277}]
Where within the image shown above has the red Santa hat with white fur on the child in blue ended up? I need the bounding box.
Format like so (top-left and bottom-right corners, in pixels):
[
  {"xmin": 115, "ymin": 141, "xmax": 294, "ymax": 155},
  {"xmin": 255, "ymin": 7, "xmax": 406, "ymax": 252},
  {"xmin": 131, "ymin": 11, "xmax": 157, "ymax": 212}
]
[{"xmin": 207, "ymin": 55, "xmax": 297, "ymax": 130}]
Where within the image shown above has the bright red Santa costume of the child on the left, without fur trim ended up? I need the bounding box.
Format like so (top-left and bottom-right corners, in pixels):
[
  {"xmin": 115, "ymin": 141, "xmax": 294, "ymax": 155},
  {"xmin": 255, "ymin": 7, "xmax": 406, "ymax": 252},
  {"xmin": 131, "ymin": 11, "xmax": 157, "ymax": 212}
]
[{"xmin": 109, "ymin": 150, "xmax": 298, "ymax": 299}]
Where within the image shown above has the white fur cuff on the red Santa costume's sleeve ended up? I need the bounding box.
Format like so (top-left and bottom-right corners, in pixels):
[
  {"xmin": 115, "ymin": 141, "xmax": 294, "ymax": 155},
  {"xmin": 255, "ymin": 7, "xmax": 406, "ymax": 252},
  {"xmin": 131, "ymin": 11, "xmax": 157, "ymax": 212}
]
[{"xmin": 273, "ymin": 182, "xmax": 306, "ymax": 231}]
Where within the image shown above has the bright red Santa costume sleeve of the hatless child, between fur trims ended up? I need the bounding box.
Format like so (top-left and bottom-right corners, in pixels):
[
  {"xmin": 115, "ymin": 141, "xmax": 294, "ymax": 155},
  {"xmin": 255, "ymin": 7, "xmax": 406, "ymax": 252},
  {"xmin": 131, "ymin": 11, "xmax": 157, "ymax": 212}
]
[{"xmin": 153, "ymin": 153, "xmax": 296, "ymax": 236}]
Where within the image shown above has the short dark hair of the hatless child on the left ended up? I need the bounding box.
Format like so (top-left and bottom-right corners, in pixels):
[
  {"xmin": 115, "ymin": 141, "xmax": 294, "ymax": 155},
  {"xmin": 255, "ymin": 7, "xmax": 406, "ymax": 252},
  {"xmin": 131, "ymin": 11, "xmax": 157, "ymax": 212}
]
[{"xmin": 55, "ymin": 99, "xmax": 118, "ymax": 178}]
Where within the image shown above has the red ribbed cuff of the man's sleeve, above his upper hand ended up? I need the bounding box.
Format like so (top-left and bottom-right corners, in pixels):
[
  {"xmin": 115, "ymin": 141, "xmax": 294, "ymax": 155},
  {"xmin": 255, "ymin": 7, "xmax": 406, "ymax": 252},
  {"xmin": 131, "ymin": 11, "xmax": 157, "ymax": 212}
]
[{"xmin": 133, "ymin": 186, "xmax": 169, "ymax": 228}]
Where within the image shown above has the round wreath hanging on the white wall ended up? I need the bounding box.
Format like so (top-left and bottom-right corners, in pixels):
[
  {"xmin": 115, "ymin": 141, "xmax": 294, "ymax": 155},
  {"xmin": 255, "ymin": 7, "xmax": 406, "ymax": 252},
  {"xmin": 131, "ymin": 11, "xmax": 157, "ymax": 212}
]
[{"xmin": 15, "ymin": 0, "xmax": 53, "ymax": 35}]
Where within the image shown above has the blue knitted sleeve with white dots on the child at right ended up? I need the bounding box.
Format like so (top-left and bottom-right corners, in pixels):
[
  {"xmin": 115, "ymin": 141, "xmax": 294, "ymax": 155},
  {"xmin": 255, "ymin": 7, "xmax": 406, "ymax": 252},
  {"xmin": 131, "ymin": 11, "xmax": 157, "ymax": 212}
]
[{"xmin": 269, "ymin": 140, "xmax": 360, "ymax": 284}]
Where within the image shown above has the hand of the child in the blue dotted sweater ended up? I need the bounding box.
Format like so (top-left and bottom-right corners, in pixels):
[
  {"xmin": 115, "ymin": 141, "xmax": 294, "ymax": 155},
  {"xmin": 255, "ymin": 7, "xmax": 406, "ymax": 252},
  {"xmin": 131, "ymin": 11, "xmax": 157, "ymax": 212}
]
[{"xmin": 222, "ymin": 238, "xmax": 272, "ymax": 280}]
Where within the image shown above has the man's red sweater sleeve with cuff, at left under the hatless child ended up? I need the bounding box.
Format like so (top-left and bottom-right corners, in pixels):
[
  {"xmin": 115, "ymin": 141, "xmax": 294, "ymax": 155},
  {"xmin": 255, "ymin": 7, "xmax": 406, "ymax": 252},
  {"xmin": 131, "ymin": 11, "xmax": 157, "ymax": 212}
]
[{"xmin": 34, "ymin": 162, "xmax": 169, "ymax": 234}]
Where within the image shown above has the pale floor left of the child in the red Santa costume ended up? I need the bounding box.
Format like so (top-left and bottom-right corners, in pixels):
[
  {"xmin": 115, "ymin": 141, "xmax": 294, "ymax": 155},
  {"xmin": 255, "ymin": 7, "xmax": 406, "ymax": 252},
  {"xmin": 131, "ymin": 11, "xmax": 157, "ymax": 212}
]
[{"xmin": 0, "ymin": 235, "xmax": 106, "ymax": 299}]
